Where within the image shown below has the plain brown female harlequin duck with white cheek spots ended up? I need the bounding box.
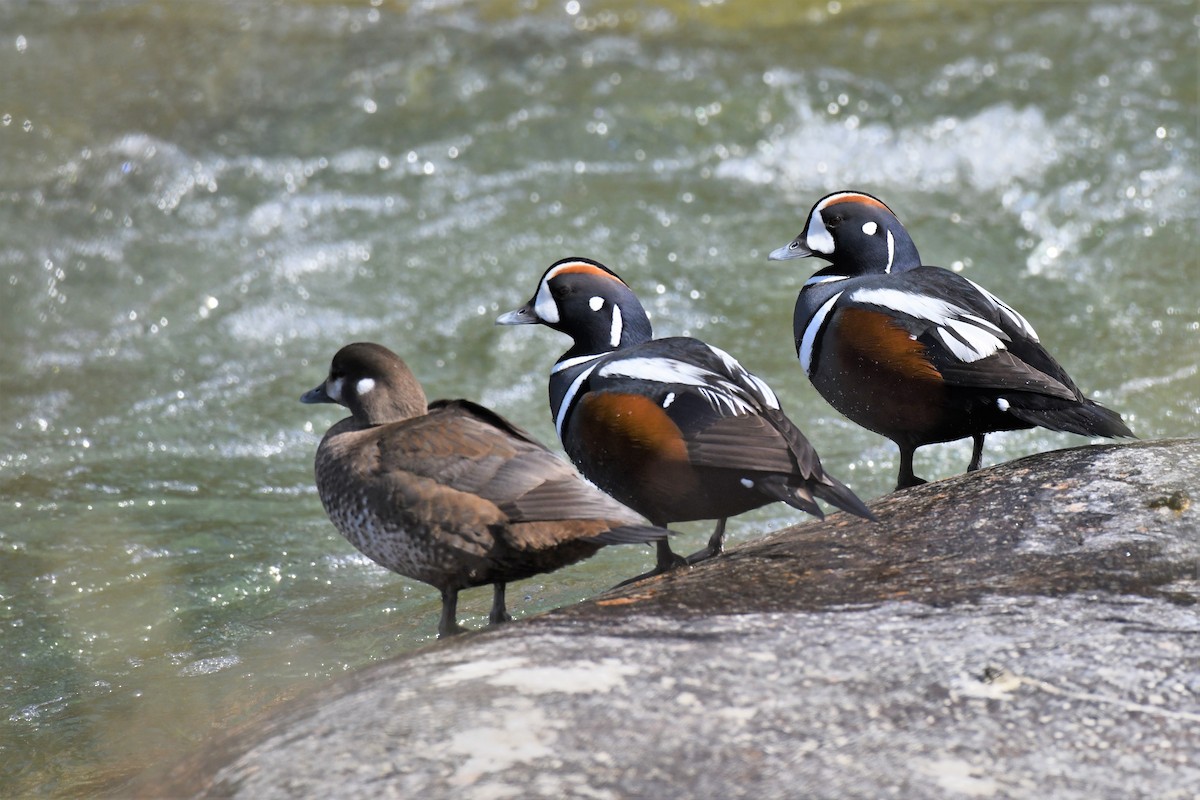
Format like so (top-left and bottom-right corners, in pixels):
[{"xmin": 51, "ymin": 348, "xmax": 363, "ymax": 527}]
[{"xmin": 300, "ymin": 343, "xmax": 667, "ymax": 637}]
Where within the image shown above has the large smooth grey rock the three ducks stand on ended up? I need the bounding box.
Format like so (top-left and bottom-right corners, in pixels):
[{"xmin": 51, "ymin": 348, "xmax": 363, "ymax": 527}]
[{"xmin": 143, "ymin": 439, "xmax": 1200, "ymax": 800}]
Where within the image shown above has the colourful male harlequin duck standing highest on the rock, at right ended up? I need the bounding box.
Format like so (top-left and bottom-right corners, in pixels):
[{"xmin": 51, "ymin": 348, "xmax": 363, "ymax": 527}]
[{"xmin": 768, "ymin": 192, "xmax": 1133, "ymax": 489}]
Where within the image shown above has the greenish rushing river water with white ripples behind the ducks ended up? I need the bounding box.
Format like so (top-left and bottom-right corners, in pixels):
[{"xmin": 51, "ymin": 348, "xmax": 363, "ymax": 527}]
[{"xmin": 0, "ymin": 0, "xmax": 1200, "ymax": 796}]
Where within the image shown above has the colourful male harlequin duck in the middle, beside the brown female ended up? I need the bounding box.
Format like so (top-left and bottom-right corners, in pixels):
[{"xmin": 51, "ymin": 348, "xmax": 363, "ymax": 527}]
[{"xmin": 496, "ymin": 258, "xmax": 874, "ymax": 572}]
